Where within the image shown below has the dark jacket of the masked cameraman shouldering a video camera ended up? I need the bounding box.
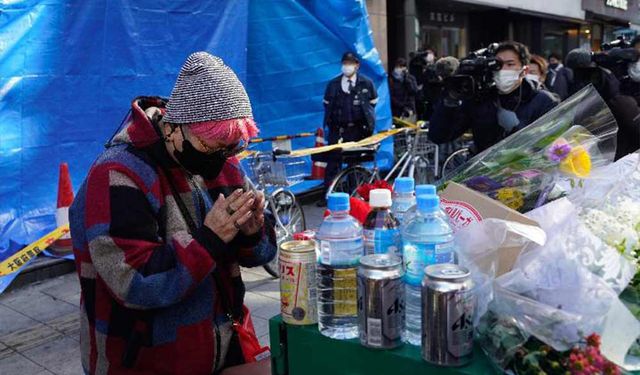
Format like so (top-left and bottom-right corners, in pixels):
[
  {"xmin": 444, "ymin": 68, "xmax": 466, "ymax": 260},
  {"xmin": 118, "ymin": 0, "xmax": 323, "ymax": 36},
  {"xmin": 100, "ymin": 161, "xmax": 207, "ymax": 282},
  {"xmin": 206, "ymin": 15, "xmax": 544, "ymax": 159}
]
[{"xmin": 429, "ymin": 79, "xmax": 558, "ymax": 152}]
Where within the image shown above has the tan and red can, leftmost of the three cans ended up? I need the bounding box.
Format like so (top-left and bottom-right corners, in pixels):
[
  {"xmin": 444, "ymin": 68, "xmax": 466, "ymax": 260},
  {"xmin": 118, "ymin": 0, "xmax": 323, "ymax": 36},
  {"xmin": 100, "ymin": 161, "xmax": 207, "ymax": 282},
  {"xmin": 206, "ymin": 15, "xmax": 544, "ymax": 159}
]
[{"xmin": 278, "ymin": 241, "xmax": 318, "ymax": 325}]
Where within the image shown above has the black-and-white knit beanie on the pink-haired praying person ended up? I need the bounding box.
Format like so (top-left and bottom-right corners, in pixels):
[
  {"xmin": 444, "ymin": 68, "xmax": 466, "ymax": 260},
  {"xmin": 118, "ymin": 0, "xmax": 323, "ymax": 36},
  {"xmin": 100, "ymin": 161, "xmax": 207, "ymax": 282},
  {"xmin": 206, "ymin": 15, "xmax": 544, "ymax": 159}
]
[{"xmin": 164, "ymin": 52, "xmax": 253, "ymax": 124}]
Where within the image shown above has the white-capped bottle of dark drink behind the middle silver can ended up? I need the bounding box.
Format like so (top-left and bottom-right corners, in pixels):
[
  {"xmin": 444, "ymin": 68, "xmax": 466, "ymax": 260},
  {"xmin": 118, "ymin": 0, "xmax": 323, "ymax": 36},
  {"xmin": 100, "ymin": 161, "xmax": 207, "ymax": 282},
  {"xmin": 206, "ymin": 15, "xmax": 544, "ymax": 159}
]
[{"xmin": 364, "ymin": 189, "xmax": 402, "ymax": 257}]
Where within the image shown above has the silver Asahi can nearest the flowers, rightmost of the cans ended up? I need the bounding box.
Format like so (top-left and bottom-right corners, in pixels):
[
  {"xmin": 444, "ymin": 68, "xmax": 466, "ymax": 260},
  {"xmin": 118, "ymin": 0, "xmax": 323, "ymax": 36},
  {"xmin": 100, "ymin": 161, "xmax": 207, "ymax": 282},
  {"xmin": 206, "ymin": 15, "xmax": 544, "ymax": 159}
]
[{"xmin": 422, "ymin": 263, "xmax": 476, "ymax": 367}]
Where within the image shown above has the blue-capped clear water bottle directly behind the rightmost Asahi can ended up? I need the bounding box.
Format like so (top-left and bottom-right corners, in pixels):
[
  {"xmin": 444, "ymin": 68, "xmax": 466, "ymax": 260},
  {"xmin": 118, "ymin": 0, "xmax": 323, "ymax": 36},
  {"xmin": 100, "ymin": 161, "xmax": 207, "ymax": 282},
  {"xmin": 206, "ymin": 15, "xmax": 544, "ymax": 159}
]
[{"xmin": 402, "ymin": 195, "xmax": 454, "ymax": 345}]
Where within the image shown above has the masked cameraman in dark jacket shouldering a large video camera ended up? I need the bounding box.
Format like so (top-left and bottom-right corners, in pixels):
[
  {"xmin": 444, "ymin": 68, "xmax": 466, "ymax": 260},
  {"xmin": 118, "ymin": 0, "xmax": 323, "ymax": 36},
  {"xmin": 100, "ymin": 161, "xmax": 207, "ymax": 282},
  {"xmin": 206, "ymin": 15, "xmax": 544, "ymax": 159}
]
[{"xmin": 429, "ymin": 42, "xmax": 558, "ymax": 152}]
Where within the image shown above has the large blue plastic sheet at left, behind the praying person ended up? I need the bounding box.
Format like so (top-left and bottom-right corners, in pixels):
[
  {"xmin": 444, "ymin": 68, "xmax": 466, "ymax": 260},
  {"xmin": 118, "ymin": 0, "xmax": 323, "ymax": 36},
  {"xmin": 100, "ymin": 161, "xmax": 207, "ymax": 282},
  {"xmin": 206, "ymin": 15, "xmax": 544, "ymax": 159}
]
[{"xmin": 0, "ymin": 0, "xmax": 249, "ymax": 260}]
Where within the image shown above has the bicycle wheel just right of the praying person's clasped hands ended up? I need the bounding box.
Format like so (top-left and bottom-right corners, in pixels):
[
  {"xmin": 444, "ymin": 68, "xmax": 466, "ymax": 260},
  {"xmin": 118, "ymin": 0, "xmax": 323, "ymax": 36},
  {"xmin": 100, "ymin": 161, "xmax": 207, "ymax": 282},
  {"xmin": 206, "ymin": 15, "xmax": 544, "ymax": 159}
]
[{"xmin": 263, "ymin": 190, "xmax": 307, "ymax": 277}]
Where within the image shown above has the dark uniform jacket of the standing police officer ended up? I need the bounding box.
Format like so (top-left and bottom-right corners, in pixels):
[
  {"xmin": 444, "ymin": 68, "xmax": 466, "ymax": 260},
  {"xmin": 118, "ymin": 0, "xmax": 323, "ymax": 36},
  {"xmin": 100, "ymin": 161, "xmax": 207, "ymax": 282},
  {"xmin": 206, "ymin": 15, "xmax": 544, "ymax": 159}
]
[{"xmin": 323, "ymin": 73, "xmax": 378, "ymax": 133}]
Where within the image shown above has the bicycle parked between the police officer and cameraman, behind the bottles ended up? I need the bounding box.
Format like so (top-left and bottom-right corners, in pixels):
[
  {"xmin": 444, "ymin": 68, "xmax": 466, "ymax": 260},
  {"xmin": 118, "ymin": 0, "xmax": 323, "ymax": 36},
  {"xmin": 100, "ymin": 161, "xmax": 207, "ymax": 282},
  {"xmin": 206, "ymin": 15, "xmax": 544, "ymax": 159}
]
[{"xmin": 327, "ymin": 121, "xmax": 439, "ymax": 196}]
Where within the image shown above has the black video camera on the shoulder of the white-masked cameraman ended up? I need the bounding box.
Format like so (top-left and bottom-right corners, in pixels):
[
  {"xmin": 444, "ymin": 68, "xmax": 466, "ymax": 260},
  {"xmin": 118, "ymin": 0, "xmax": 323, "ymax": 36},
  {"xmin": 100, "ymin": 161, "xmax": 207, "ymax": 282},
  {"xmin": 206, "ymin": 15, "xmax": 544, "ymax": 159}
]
[{"xmin": 444, "ymin": 43, "xmax": 502, "ymax": 100}]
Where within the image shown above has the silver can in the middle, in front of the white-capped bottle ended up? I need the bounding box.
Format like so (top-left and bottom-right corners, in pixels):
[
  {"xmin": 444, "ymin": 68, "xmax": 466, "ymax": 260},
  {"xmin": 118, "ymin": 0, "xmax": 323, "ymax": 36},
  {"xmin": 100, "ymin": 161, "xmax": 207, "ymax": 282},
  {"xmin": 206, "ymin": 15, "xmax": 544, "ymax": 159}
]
[{"xmin": 358, "ymin": 254, "xmax": 405, "ymax": 349}]
